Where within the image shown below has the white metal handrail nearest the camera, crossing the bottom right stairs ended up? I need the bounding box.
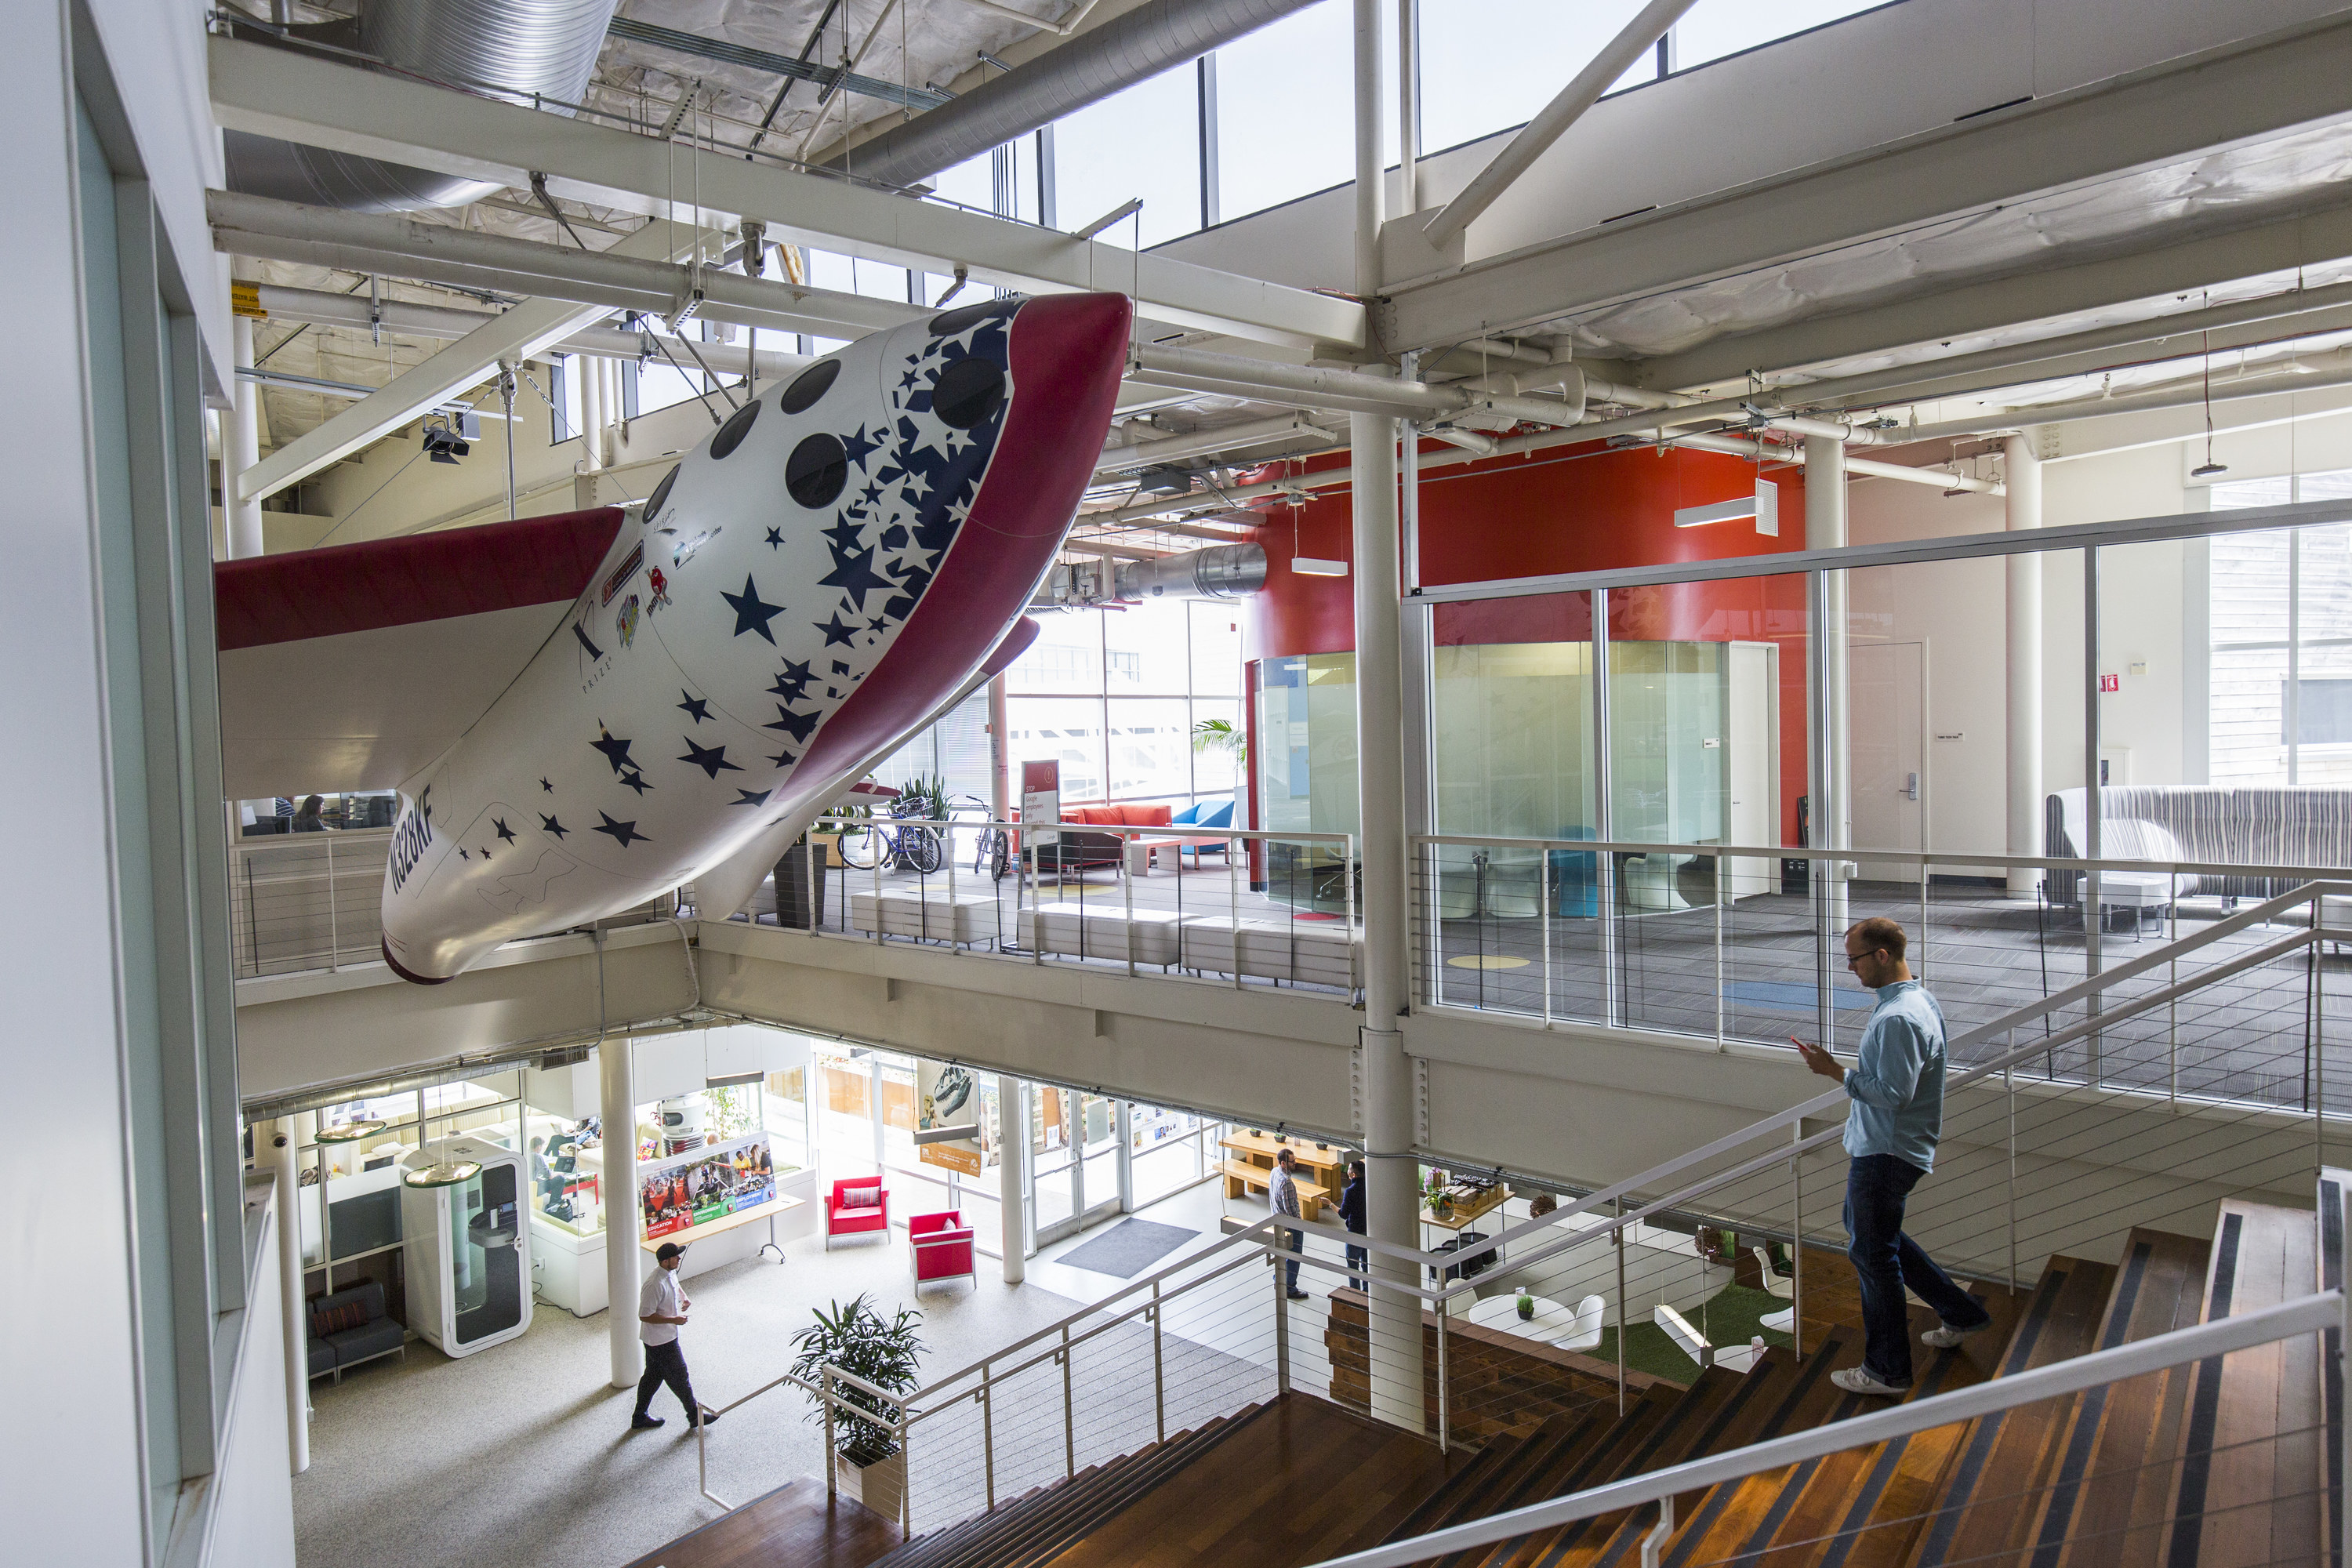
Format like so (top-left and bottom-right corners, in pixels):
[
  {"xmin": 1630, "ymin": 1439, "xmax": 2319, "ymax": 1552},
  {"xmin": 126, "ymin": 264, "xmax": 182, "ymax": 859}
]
[{"xmin": 1315, "ymin": 1290, "xmax": 2345, "ymax": 1568}]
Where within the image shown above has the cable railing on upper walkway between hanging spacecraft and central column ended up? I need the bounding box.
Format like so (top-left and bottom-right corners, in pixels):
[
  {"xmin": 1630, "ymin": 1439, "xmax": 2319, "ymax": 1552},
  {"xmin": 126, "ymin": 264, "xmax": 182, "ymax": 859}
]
[{"xmin": 729, "ymin": 815, "xmax": 1364, "ymax": 999}]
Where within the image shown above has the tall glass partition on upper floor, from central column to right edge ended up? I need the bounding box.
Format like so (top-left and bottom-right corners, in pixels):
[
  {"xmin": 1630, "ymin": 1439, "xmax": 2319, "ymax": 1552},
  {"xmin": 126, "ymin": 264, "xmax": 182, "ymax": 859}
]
[{"xmin": 1402, "ymin": 487, "xmax": 2352, "ymax": 1100}]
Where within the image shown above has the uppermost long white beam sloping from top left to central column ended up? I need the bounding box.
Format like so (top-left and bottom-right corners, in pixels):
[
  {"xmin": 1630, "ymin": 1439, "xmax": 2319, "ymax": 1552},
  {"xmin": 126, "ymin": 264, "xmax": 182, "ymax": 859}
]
[{"xmin": 209, "ymin": 38, "xmax": 1364, "ymax": 348}]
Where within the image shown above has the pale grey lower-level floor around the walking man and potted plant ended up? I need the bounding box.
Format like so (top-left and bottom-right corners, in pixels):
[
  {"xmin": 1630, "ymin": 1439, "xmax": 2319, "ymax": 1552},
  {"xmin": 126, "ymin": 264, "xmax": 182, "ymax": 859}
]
[{"xmin": 294, "ymin": 1236, "xmax": 1091, "ymax": 1568}]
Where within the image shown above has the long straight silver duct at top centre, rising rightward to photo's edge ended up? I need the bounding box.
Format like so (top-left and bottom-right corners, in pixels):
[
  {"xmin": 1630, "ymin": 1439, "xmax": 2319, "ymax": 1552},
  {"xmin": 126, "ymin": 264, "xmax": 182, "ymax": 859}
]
[{"xmin": 826, "ymin": 0, "xmax": 1315, "ymax": 187}]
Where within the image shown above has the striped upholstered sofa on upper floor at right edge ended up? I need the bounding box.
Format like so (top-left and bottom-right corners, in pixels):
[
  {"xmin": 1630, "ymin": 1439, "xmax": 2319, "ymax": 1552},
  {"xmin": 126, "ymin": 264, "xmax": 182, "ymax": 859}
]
[{"xmin": 2044, "ymin": 785, "xmax": 2352, "ymax": 902}]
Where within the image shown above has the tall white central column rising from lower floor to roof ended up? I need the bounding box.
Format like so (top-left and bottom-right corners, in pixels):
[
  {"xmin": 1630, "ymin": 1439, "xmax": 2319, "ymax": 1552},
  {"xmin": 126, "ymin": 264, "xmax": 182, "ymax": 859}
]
[{"xmin": 1348, "ymin": 0, "xmax": 1425, "ymax": 1432}]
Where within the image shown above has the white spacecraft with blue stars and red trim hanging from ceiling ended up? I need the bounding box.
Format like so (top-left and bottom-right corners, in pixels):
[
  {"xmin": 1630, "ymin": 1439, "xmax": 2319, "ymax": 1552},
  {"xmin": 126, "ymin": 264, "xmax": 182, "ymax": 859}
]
[{"xmin": 216, "ymin": 294, "xmax": 1129, "ymax": 982}]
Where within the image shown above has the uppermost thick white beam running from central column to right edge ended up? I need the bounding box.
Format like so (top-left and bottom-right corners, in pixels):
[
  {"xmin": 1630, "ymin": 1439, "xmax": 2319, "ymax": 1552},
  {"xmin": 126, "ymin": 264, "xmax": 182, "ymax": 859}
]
[{"xmin": 1381, "ymin": 12, "xmax": 2352, "ymax": 348}]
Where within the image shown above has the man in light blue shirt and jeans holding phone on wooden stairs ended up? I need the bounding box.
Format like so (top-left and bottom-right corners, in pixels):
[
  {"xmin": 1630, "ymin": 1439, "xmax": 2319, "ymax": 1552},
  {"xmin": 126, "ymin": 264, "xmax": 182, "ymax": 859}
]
[{"xmin": 1790, "ymin": 916, "xmax": 1992, "ymax": 1399}]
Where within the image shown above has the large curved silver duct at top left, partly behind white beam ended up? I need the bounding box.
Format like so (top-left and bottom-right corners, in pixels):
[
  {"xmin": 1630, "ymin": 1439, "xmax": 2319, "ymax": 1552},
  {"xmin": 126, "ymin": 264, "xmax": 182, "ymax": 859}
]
[{"xmin": 223, "ymin": 0, "xmax": 619, "ymax": 212}]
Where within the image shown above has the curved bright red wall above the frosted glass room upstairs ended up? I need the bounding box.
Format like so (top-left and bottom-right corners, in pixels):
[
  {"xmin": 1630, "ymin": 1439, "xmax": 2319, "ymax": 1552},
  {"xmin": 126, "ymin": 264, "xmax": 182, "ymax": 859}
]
[{"xmin": 1242, "ymin": 442, "xmax": 1806, "ymax": 844}]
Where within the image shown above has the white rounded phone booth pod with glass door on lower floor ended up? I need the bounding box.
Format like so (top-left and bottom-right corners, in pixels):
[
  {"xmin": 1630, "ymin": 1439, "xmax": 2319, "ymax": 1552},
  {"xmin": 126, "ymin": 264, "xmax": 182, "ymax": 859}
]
[{"xmin": 400, "ymin": 1138, "xmax": 532, "ymax": 1356}]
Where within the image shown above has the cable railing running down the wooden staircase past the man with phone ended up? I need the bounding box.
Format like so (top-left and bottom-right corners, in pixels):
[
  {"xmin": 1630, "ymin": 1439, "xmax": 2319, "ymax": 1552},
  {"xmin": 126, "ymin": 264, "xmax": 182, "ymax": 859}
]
[{"xmin": 687, "ymin": 881, "xmax": 2352, "ymax": 1561}]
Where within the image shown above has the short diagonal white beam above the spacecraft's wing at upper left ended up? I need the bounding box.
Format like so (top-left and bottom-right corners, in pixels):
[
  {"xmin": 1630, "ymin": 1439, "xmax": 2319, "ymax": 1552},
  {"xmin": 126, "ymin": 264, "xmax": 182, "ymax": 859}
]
[{"xmin": 238, "ymin": 217, "xmax": 694, "ymax": 501}]
